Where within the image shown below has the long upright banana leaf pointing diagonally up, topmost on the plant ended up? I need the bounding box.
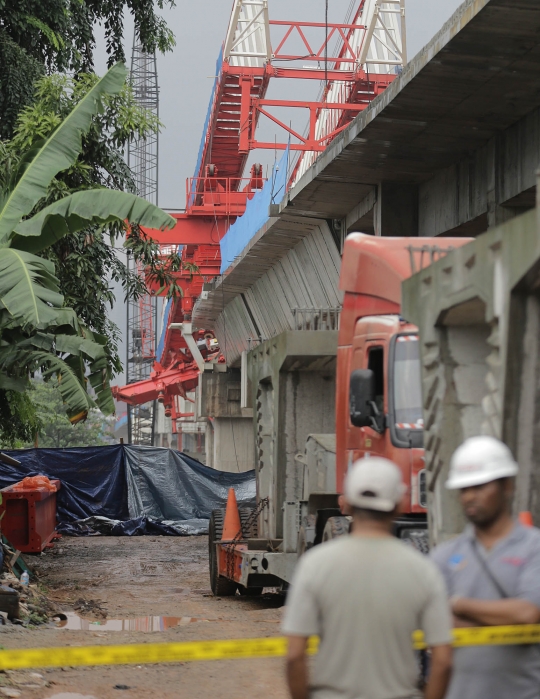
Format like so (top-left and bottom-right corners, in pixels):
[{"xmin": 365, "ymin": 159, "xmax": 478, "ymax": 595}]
[{"xmin": 0, "ymin": 63, "xmax": 127, "ymax": 245}]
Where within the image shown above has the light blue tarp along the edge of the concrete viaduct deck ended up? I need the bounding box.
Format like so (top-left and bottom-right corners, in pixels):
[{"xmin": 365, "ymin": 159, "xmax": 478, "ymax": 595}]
[{"xmin": 219, "ymin": 147, "xmax": 289, "ymax": 274}]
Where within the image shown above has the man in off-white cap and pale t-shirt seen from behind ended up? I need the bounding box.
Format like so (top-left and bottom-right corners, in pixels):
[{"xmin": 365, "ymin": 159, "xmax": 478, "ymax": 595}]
[{"xmin": 283, "ymin": 457, "xmax": 454, "ymax": 699}]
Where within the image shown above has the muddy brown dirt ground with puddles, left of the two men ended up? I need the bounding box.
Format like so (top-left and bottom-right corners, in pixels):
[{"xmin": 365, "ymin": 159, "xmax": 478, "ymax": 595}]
[{"xmin": 0, "ymin": 536, "xmax": 288, "ymax": 699}]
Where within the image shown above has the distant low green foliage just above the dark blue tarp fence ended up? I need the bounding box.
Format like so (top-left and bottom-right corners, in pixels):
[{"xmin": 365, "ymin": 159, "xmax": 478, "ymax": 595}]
[{"xmin": 25, "ymin": 379, "xmax": 114, "ymax": 448}]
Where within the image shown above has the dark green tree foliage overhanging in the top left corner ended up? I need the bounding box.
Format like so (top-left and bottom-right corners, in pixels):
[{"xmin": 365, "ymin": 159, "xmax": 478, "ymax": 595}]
[{"xmin": 0, "ymin": 0, "xmax": 174, "ymax": 138}]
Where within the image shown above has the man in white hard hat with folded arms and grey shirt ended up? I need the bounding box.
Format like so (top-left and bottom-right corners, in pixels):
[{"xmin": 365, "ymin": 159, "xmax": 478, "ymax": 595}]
[{"xmin": 432, "ymin": 437, "xmax": 540, "ymax": 699}]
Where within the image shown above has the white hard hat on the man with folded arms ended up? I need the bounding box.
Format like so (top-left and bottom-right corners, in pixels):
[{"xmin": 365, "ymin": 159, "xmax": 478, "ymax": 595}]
[{"xmin": 446, "ymin": 436, "xmax": 519, "ymax": 490}]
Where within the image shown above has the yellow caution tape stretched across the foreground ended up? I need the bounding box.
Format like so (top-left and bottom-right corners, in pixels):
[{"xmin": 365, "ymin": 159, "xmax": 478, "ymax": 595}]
[{"xmin": 0, "ymin": 624, "xmax": 540, "ymax": 670}]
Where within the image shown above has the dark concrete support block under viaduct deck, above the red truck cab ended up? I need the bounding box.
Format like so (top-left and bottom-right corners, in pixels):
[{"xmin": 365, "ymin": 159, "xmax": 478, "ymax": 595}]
[{"xmin": 373, "ymin": 182, "xmax": 418, "ymax": 237}]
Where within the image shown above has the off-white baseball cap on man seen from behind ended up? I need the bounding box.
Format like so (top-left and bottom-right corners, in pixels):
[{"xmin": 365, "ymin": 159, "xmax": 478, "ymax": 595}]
[{"xmin": 345, "ymin": 456, "xmax": 407, "ymax": 512}]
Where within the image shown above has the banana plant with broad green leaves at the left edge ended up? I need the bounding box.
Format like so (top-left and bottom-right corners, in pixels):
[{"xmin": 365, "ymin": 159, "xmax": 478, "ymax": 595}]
[{"xmin": 0, "ymin": 63, "xmax": 175, "ymax": 422}]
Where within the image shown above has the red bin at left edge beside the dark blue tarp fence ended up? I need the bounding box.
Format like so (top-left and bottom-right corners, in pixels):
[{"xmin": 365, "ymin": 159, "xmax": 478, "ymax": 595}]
[{"xmin": 0, "ymin": 480, "xmax": 60, "ymax": 553}]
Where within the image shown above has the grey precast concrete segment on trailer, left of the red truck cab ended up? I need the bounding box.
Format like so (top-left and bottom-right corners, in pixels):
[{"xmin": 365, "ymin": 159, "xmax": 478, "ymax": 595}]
[{"xmin": 248, "ymin": 331, "xmax": 337, "ymax": 538}]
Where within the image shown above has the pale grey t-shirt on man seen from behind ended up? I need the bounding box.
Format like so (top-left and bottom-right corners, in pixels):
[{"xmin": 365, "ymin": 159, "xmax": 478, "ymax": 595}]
[{"xmin": 283, "ymin": 536, "xmax": 450, "ymax": 699}]
